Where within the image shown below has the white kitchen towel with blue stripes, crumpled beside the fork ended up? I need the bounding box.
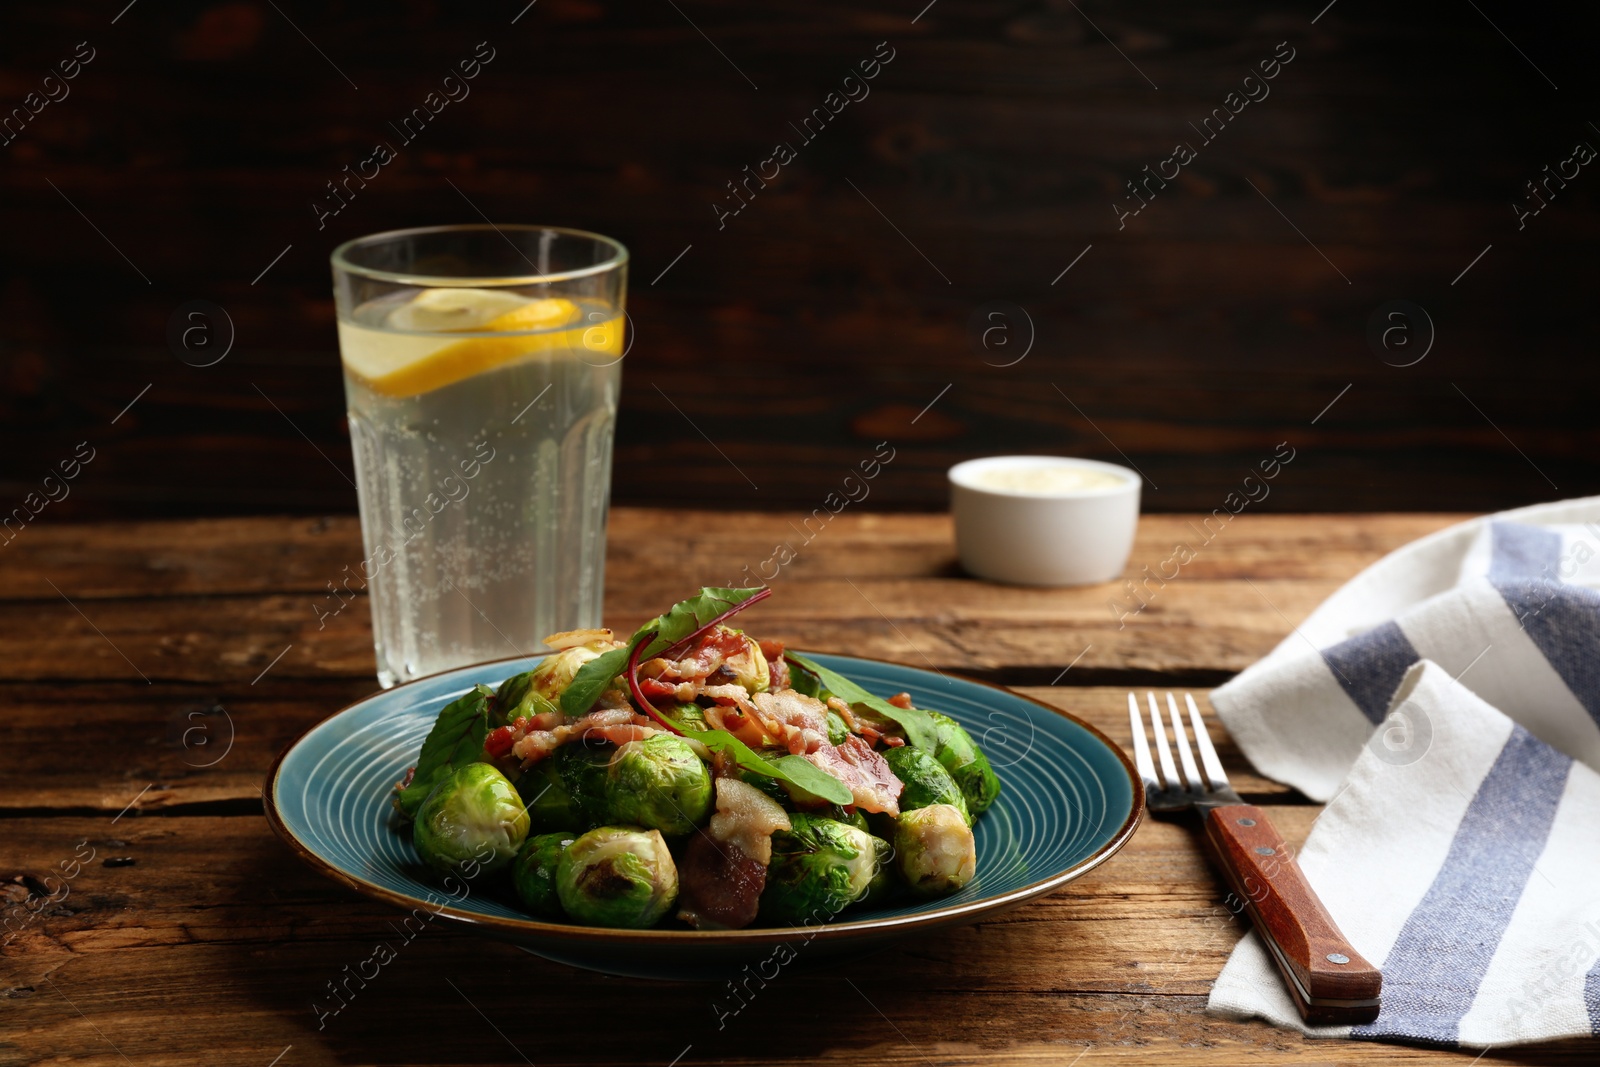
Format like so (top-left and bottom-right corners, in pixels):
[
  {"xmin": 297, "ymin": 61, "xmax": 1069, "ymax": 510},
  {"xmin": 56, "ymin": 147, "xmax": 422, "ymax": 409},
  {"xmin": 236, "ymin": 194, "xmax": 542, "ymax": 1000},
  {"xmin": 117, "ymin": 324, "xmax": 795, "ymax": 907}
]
[{"xmin": 1210, "ymin": 498, "xmax": 1600, "ymax": 1048}]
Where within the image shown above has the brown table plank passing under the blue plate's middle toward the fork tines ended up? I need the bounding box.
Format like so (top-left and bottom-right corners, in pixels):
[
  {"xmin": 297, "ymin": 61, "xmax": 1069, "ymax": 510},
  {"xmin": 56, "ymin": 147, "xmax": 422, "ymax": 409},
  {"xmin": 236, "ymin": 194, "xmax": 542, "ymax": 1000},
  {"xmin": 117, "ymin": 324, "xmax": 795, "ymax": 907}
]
[{"xmin": 0, "ymin": 678, "xmax": 1302, "ymax": 814}]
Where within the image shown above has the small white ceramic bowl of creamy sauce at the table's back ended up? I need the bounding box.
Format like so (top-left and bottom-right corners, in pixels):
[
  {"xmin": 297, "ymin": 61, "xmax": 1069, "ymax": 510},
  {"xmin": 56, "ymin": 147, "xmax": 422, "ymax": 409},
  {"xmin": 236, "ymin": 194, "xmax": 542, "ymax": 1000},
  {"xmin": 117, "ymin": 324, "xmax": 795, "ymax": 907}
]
[{"xmin": 950, "ymin": 456, "xmax": 1141, "ymax": 585}]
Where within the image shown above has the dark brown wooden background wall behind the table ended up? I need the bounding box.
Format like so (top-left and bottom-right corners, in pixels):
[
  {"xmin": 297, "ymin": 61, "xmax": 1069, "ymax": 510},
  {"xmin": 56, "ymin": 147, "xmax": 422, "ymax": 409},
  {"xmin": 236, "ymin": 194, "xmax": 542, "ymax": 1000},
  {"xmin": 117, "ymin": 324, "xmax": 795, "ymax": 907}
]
[{"xmin": 0, "ymin": 0, "xmax": 1600, "ymax": 520}]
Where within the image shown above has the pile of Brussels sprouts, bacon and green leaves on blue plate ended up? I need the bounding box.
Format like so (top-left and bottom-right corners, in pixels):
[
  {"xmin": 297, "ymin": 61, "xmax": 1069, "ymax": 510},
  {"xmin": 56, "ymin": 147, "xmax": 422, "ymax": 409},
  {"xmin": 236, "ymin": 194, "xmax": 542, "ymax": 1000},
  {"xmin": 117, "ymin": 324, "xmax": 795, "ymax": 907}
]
[{"xmin": 394, "ymin": 589, "xmax": 1000, "ymax": 929}]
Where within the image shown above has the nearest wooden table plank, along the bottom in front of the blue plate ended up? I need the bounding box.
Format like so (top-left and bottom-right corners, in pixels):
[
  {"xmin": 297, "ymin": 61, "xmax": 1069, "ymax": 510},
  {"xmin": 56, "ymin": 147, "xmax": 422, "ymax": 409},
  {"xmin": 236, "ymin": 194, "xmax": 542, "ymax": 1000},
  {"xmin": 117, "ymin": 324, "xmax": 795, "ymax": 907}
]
[{"xmin": 0, "ymin": 808, "xmax": 1600, "ymax": 1065}]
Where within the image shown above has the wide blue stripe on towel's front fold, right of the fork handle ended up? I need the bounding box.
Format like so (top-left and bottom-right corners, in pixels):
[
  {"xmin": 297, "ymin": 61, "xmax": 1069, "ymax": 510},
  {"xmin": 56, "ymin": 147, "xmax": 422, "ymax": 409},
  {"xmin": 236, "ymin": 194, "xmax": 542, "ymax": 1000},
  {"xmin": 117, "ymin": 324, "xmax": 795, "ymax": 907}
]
[{"xmin": 1350, "ymin": 726, "xmax": 1573, "ymax": 1045}]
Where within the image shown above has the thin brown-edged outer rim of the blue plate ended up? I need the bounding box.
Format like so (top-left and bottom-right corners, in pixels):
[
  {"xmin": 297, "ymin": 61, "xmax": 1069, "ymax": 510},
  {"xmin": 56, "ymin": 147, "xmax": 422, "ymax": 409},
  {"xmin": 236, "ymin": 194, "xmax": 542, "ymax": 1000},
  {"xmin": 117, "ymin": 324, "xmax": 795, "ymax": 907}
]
[{"xmin": 261, "ymin": 653, "xmax": 1146, "ymax": 947}]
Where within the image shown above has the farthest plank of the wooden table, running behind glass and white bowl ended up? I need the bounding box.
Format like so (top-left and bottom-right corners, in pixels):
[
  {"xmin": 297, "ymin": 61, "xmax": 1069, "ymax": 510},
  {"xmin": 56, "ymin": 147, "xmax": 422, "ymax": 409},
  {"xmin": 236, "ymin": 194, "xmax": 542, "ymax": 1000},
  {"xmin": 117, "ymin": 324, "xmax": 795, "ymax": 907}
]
[{"xmin": 0, "ymin": 508, "xmax": 1467, "ymax": 601}]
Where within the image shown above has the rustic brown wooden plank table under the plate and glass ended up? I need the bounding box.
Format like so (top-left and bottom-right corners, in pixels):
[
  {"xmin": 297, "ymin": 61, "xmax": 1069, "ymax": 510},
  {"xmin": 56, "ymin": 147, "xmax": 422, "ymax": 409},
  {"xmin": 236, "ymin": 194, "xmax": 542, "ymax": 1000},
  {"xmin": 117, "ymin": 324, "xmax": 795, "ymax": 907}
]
[{"xmin": 0, "ymin": 510, "xmax": 1600, "ymax": 1067}]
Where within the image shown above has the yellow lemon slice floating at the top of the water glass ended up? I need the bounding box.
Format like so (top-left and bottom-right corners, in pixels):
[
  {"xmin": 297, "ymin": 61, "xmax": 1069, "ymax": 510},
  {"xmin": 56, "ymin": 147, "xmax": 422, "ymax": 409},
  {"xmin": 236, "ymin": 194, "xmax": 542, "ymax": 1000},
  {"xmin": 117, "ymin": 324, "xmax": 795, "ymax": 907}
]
[{"xmin": 339, "ymin": 288, "xmax": 622, "ymax": 397}]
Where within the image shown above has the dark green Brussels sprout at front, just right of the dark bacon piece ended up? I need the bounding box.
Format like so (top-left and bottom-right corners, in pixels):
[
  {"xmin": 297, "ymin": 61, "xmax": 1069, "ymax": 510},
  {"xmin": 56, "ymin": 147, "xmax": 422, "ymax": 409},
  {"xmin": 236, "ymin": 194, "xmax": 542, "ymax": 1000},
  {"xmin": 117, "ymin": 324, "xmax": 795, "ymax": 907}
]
[{"xmin": 762, "ymin": 814, "xmax": 878, "ymax": 923}]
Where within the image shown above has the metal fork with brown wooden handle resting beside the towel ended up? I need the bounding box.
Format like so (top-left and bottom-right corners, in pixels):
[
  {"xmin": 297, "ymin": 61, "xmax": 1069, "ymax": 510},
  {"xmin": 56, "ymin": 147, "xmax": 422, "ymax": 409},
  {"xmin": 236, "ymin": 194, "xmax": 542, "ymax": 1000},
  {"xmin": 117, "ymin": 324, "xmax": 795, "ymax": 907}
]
[{"xmin": 1128, "ymin": 693, "xmax": 1382, "ymax": 1024}]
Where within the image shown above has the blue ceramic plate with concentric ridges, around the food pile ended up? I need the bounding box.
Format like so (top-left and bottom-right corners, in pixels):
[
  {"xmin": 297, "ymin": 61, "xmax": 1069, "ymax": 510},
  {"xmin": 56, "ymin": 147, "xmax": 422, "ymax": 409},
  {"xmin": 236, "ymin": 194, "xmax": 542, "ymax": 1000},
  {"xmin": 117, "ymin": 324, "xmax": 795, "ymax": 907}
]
[{"xmin": 262, "ymin": 654, "xmax": 1144, "ymax": 981}]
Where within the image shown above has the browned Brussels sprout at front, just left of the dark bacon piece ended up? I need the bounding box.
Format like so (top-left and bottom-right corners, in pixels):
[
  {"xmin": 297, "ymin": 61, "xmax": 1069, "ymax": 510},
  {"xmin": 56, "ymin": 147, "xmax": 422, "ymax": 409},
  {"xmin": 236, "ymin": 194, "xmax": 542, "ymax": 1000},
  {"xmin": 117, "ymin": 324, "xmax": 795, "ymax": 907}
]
[{"xmin": 555, "ymin": 825, "xmax": 678, "ymax": 929}]
